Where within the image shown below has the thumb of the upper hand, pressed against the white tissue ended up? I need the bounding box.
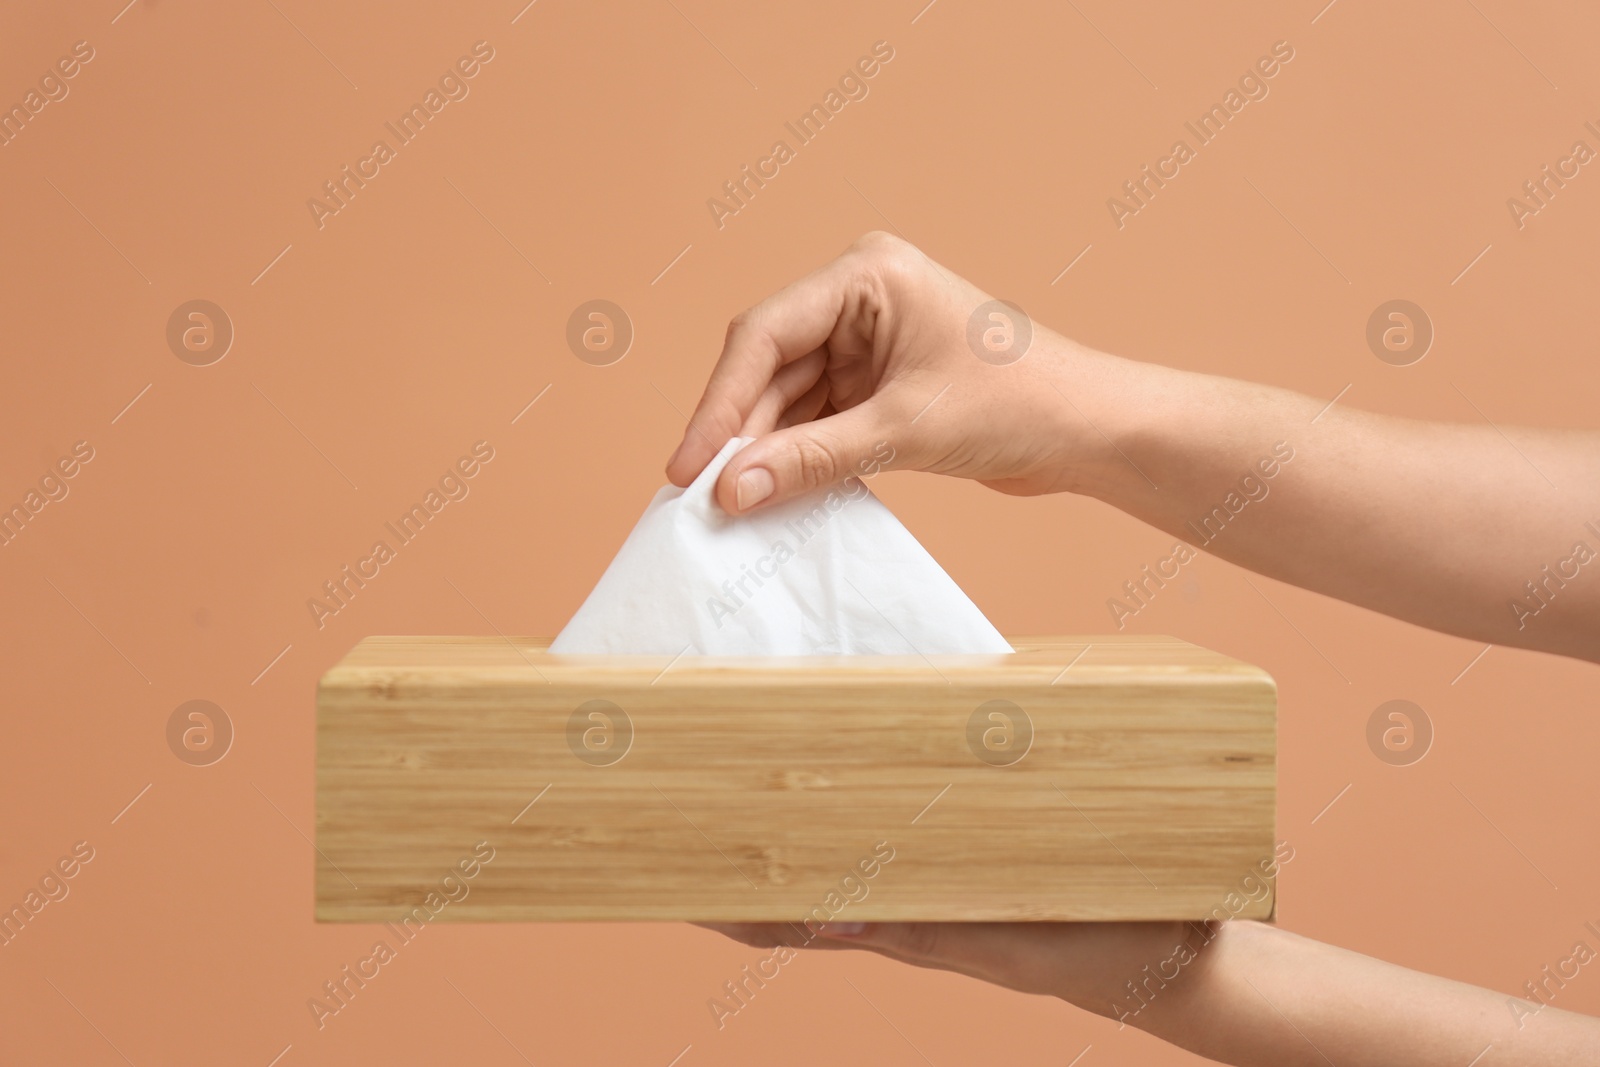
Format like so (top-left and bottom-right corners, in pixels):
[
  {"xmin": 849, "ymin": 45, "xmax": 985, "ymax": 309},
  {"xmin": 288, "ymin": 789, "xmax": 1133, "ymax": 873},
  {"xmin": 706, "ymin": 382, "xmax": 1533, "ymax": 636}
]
[{"xmin": 717, "ymin": 397, "xmax": 906, "ymax": 515}]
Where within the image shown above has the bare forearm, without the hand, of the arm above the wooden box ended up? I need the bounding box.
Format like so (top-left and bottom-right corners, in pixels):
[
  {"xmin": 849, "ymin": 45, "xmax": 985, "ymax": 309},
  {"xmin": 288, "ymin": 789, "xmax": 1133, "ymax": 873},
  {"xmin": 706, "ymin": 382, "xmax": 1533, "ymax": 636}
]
[{"xmin": 1056, "ymin": 342, "xmax": 1600, "ymax": 661}]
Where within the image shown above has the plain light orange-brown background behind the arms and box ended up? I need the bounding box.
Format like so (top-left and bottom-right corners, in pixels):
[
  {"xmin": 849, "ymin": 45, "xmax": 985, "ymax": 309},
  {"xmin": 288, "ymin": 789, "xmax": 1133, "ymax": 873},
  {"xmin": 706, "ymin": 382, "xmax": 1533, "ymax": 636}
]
[{"xmin": 0, "ymin": 0, "xmax": 1600, "ymax": 1067}]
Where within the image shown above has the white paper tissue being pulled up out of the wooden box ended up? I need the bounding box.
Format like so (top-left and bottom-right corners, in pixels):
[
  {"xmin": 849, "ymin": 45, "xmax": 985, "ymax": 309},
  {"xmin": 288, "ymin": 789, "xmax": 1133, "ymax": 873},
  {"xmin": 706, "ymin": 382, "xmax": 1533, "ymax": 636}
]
[{"xmin": 550, "ymin": 437, "xmax": 1013, "ymax": 656}]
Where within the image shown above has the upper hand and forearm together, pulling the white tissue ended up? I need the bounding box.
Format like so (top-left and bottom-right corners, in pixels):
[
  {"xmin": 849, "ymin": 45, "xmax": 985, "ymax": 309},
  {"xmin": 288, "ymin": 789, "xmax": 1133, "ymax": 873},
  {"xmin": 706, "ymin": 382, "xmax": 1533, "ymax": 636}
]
[{"xmin": 667, "ymin": 234, "xmax": 1600, "ymax": 662}]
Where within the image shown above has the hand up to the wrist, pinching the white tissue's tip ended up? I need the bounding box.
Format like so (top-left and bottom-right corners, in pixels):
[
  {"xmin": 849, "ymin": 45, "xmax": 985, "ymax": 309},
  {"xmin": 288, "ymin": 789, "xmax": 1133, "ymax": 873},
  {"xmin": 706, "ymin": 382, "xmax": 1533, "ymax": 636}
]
[{"xmin": 667, "ymin": 234, "xmax": 1093, "ymax": 514}]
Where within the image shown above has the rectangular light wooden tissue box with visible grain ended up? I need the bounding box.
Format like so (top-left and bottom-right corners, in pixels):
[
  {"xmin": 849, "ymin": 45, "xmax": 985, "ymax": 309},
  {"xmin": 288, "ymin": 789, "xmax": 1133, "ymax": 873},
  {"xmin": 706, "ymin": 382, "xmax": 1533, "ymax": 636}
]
[{"xmin": 317, "ymin": 635, "xmax": 1277, "ymax": 929}]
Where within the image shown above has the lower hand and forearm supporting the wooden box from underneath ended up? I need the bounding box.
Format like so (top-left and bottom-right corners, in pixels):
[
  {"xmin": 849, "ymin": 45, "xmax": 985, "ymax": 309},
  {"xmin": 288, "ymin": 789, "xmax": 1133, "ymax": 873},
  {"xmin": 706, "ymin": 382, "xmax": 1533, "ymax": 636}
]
[{"xmin": 709, "ymin": 920, "xmax": 1600, "ymax": 1067}]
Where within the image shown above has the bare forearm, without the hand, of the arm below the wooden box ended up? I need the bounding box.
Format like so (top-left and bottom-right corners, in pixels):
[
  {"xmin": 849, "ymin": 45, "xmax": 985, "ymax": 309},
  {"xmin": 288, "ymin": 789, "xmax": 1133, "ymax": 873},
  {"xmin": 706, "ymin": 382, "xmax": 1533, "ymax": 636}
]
[{"xmin": 1131, "ymin": 921, "xmax": 1600, "ymax": 1067}]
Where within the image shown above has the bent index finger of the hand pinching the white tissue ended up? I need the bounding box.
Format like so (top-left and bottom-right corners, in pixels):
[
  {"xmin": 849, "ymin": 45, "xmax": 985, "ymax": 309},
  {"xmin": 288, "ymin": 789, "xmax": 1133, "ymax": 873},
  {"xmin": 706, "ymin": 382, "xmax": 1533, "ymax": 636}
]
[{"xmin": 667, "ymin": 253, "xmax": 850, "ymax": 485}]
